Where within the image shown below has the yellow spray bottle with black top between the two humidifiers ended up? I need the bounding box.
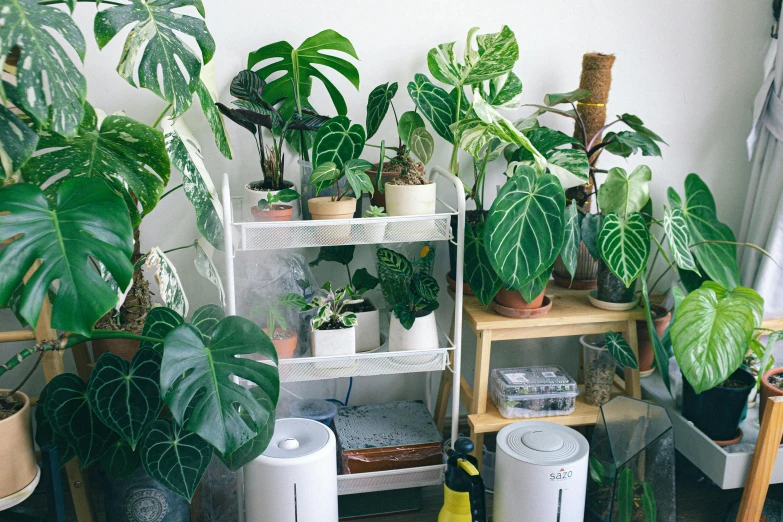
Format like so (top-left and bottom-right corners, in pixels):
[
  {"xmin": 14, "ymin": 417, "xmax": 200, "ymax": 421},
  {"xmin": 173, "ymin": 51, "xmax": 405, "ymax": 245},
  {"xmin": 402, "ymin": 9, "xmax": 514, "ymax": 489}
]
[{"xmin": 438, "ymin": 438, "xmax": 487, "ymax": 522}]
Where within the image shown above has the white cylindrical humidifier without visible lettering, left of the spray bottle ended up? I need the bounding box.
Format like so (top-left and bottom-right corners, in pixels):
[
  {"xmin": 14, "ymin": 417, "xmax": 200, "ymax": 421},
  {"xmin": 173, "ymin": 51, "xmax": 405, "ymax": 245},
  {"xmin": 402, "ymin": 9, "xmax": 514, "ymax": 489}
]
[{"xmin": 242, "ymin": 419, "xmax": 337, "ymax": 522}]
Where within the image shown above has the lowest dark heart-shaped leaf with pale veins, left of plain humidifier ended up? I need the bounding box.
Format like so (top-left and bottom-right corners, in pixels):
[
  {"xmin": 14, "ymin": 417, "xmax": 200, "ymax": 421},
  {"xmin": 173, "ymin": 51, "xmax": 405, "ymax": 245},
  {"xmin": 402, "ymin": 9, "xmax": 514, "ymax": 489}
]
[{"xmin": 141, "ymin": 420, "xmax": 212, "ymax": 501}]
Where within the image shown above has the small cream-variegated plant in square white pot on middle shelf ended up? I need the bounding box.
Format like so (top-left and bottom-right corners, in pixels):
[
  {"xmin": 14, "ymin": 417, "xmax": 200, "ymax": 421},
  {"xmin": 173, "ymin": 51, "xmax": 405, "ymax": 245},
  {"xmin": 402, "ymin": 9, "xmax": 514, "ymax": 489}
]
[{"xmin": 286, "ymin": 281, "xmax": 362, "ymax": 357}]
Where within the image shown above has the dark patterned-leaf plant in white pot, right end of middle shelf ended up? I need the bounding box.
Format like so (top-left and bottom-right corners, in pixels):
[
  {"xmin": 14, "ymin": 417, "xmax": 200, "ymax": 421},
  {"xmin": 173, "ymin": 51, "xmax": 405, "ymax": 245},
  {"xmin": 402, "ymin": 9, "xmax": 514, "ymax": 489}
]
[{"xmin": 378, "ymin": 247, "xmax": 440, "ymax": 352}]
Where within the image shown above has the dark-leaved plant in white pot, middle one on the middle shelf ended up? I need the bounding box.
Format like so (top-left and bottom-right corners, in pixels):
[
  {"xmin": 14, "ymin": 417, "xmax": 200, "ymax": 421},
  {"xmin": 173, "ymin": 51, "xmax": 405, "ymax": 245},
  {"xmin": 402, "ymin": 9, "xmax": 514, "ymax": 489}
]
[{"xmin": 310, "ymin": 245, "xmax": 381, "ymax": 352}]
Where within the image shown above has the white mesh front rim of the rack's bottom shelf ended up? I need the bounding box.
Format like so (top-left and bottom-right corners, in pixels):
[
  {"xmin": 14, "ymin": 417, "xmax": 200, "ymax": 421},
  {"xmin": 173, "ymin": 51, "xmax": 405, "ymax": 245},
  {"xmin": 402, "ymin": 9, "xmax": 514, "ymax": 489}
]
[{"xmin": 337, "ymin": 464, "xmax": 445, "ymax": 495}]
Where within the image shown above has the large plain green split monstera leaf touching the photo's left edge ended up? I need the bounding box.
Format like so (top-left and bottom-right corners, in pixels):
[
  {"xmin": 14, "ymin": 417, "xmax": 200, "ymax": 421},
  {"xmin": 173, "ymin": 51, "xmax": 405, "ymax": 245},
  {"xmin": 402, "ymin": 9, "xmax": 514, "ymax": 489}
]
[{"xmin": 0, "ymin": 179, "xmax": 133, "ymax": 335}]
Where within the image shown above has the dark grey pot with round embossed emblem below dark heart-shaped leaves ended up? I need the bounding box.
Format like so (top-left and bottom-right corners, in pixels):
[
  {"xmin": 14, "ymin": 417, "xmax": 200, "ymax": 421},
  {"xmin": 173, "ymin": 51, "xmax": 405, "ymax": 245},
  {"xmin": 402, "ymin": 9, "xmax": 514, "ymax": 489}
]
[{"xmin": 101, "ymin": 467, "xmax": 190, "ymax": 522}]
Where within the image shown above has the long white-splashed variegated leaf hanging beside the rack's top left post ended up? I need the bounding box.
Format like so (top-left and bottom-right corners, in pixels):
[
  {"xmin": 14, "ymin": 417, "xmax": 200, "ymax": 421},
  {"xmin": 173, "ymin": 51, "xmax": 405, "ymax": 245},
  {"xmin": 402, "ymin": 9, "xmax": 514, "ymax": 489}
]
[{"xmin": 162, "ymin": 118, "xmax": 223, "ymax": 250}]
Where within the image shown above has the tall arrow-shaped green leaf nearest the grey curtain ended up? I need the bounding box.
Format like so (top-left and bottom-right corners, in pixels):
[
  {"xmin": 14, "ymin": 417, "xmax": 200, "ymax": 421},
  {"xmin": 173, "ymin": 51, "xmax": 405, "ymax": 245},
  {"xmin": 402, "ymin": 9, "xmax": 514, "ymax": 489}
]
[{"xmin": 668, "ymin": 174, "xmax": 739, "ymax": 289}]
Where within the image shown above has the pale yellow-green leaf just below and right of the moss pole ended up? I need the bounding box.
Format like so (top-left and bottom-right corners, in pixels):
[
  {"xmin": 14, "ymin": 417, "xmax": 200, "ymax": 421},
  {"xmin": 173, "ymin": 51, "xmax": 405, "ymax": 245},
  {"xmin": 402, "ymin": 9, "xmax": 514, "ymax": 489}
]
[{"xmin": 598, "ymin": 165, "xmax": 652, "ymax": 217}]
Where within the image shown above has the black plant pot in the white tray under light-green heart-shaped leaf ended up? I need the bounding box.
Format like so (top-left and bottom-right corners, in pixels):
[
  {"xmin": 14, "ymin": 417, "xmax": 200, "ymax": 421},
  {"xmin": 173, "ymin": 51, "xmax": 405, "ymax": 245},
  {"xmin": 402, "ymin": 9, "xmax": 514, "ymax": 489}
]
[{"xmin": 682, "ymin": 368, "xmax": 756, "ymax": 441}]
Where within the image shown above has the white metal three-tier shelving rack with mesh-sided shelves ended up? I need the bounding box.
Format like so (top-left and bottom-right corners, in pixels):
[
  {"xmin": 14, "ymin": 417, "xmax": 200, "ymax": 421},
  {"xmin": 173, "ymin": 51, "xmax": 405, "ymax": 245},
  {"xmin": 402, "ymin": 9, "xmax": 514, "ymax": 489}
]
[{"xmin": 222, "ymin": 167, "xmax": 465, "ymax": 502}]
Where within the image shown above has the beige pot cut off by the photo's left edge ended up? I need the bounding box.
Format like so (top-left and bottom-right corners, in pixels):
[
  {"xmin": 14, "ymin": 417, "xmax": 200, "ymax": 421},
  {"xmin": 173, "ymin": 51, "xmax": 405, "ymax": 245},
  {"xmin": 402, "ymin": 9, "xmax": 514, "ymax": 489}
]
[{"xmin": 0, "ymin": 390, "xmax": 38, "ymax": 498}]
